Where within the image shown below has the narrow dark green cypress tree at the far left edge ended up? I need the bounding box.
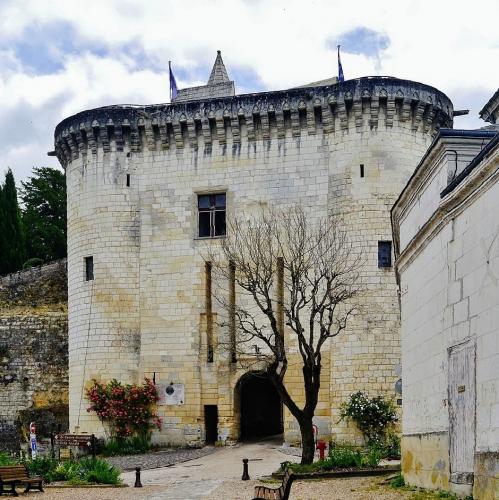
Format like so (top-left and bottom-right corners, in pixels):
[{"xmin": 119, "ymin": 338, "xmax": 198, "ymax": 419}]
[{"xmin": 0, "ymin": 168, "xmax": 26, "ymax": 274}]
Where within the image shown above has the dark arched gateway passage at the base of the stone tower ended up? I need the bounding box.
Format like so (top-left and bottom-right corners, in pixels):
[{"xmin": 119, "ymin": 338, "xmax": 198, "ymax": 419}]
[{"xmin": 239, "ymin": 372, "xmax": 283, "ymax": 439}]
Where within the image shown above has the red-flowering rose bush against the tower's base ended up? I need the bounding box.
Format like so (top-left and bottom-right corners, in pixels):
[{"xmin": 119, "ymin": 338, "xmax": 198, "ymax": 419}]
[{"xmin": 86, "ymin": 378, "xmax": 161, "ymax": 439}]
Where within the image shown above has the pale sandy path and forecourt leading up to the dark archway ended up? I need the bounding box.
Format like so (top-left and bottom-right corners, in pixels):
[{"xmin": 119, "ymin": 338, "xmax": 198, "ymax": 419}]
[{"xmin": 36, "ymin": 440, "xmax": 411, "ymax": 500}]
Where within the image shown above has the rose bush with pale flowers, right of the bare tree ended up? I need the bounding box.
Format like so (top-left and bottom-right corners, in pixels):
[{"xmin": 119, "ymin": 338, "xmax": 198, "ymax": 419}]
[{"xmin": 340, "ymin": 391, "xmax": 397, "ymax": 444}]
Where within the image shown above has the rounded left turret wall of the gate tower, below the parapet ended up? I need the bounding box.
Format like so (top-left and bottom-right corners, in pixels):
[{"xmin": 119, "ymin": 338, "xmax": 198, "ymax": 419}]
[{"xmin": 66, "ymin": 144, "xmax": 141, "ymax": 433}]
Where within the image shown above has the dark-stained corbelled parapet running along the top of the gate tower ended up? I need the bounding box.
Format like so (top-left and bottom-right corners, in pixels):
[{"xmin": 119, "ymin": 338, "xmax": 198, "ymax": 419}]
[{"xmin": 55, "ymin": 77, "xmax": 453, "ymax": 166}]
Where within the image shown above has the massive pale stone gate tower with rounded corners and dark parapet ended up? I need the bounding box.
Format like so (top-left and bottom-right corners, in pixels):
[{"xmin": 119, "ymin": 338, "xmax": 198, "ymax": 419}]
[{"xmin": 55, "ymin": 53, "xmax": 453, "ymax": 444}]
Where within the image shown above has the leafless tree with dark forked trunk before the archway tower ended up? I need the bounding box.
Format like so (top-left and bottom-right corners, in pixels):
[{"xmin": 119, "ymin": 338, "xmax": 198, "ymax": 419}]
[{"xmin": 207, "ymin": 206, "xmax": 361, "ymax": 464}]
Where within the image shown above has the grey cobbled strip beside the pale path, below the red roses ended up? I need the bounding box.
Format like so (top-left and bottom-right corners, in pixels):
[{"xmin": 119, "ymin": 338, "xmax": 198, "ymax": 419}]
[{"xmin": 106, "ymin": 446, "xmax": 215, "ymax": 471}]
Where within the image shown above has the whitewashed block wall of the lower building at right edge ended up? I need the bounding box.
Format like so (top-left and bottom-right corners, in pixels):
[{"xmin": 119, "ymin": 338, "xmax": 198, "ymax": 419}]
[{"xmin": 394, "ymin": 133, "xmax": 499, "ymax": 498}]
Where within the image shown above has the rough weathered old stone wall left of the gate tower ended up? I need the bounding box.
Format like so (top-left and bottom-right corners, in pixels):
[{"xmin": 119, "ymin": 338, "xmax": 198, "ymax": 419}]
[{"xmin": 0, "ymin": 260, "xmax": 68, "ymax": 451}]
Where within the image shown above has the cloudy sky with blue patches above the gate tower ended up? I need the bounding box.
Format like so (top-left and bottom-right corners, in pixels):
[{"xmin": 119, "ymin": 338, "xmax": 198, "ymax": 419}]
[{"xmin": 0, "ymin": 0, "xmax": 499, "ymax": 184}]
